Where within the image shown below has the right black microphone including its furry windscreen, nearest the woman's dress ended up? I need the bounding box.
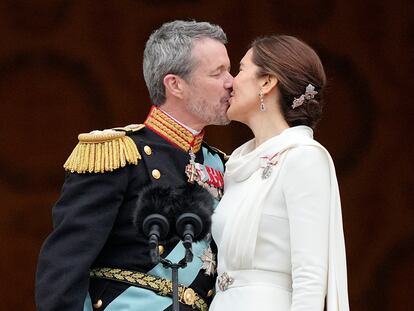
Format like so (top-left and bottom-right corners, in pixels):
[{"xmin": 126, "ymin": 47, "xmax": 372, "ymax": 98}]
[{"xmin": 173, "ymin": 183, "xmax": 214, "ymax": 254}]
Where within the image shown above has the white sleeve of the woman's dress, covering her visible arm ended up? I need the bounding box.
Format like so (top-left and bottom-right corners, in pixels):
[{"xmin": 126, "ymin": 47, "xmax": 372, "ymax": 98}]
[{"xmin": 283, "ymin": 146, "xmax": 330, "ymax": 311}]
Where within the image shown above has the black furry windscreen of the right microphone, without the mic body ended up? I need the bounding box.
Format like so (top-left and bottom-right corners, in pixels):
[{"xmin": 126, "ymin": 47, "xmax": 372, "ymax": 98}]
[{"xmin": 173, "ymin": 183, "xmax": 214, "ymax": 242}]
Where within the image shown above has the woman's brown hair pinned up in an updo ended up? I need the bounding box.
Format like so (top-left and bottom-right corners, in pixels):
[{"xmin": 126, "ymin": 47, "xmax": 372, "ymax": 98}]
[{"xmin": 251, "ymin": 35, "xmax": 326, "ymax": 129}]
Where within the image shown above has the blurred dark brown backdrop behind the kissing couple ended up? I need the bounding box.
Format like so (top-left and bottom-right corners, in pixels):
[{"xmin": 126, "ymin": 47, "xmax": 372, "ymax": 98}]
[{"xmin": 0, "ymin": 0, "xmax": 414, "ymax": 311}]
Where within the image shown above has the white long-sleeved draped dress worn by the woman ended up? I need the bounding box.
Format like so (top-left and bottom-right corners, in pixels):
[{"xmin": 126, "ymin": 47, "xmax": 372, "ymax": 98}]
[{"xmin": 209, "ymin": 126, "xmax": 349, "ymax": 311}]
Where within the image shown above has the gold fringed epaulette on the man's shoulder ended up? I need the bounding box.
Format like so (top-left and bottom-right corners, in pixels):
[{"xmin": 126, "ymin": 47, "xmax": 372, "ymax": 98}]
[{"xmin": 63, "ymin": 124, "xmax": 145, "ymax": 173}]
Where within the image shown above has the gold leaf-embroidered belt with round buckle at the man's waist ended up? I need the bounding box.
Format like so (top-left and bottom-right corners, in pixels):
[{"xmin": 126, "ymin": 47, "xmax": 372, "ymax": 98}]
[{"xmin": 89, "ymin": 268, "xmax": 208, "ymax": 311}]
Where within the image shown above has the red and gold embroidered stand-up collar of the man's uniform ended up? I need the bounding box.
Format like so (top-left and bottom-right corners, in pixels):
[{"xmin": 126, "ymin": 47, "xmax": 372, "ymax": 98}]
[{"xmin": 144, "ymin": 106, "xmax": 204, "ymax": 153}]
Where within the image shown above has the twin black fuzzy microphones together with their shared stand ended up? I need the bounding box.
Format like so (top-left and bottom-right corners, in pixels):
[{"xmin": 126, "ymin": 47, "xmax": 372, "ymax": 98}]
[{"xmin": 138, "ymin": 187, "xmax": 213, "ymax": 311}]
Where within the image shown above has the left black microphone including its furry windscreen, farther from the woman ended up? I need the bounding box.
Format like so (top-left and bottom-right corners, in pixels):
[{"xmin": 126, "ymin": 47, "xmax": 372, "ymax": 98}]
[{"xmin": 133, "ymin": 186, "xmax": 176, "ymax": 263}]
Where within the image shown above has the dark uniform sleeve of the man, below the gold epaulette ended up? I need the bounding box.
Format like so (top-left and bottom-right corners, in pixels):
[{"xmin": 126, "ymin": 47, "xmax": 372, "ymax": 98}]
[{"xmin": 36, "ymin": 168, "xmax": 128, "ymax": 311}]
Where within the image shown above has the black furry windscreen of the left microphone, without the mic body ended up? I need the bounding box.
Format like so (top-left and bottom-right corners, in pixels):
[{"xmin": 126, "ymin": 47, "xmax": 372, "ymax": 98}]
[{"xmin": 133, "ymin": 185, "xmax": 177, "ymax": 236}]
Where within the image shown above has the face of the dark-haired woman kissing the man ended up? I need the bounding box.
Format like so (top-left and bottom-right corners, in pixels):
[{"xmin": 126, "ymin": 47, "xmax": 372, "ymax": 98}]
[{"xmin": 227, "ymin": 49, "xmax": 260, "ymax": 123}]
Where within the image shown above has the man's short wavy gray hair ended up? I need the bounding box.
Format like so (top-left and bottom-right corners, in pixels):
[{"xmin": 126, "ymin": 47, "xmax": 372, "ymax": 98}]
[{"xmin": 143, "ymin": 20, "xmax": 227, "ymax": 106}]
